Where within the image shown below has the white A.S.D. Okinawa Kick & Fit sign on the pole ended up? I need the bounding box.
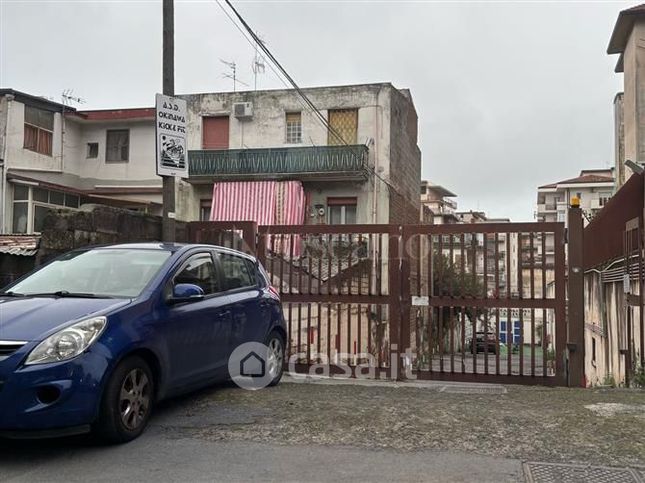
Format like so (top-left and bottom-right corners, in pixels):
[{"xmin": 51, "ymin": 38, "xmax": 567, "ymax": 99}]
[{"xmin": 155, "ymin": 94, "xmax": 188, "ymax": 178}]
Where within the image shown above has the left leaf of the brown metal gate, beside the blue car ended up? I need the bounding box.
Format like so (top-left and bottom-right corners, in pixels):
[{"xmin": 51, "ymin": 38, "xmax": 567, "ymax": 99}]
[{"xmin": 257, "ymin": 225, "xmax": 401, "ymax": 377}]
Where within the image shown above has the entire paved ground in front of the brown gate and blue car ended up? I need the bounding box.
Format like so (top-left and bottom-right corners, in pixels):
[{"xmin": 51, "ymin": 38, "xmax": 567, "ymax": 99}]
[{"xmin": 0, "ymin": 378, "xmax": 645, "ymax": 482}]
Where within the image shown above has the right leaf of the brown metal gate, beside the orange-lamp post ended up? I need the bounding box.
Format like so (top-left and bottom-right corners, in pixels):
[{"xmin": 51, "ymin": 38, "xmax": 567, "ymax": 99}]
[{"xmin": 401, "ymin": 223, "xmax": 567, "ymax": 385}]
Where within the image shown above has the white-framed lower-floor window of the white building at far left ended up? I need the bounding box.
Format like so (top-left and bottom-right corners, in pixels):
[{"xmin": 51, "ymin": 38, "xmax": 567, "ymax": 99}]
[{"xmin": 12, "ymin": 184, "xmax": 80, "ymax": 233}]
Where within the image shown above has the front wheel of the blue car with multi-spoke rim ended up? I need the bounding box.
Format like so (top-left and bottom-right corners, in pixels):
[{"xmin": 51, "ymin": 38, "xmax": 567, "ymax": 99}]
[{"xmin": 96, "ymin": 356, "xmax": 155, "ymax": 443}]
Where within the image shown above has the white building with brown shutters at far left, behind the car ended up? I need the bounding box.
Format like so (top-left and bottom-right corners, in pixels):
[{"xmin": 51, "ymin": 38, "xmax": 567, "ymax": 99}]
[{"xmin": 0, "ymin": 89, "xmax": 161, "ymax": 233}]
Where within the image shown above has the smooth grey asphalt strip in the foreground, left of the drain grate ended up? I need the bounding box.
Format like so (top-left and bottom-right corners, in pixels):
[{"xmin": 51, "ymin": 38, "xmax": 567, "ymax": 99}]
[{"xmin": 0, "ymin": 436, "xmax": 522, "ymax": 482}]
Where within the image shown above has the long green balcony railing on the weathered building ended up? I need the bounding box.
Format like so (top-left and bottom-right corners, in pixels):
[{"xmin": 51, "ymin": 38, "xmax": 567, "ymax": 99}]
[{"xmin": 188, "ymin": 144, "xmax": 368, "ymax": 183}]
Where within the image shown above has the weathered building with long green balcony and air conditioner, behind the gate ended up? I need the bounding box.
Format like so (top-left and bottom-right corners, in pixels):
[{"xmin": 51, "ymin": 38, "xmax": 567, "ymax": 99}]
[{"xmin": 178, "ymin": 83, "xmax": 421, "ymax": 224}]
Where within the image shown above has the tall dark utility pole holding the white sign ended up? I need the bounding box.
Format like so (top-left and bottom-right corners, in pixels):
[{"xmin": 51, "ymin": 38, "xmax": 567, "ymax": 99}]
[{"xmin": 161, "ymin": 0, "xmax": 176, "ymax": 242}]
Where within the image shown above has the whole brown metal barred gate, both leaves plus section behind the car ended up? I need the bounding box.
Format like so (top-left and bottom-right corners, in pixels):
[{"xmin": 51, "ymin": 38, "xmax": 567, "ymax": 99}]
[{"xmin": 188, "ymin": 222, "xmax": 566, "ymax": 385}]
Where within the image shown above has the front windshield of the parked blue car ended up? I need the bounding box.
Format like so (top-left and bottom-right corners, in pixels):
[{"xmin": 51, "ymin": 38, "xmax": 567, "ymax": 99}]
[{"xmin": 7, "ymin": 248, "xmax": 170, "ymax": 298}]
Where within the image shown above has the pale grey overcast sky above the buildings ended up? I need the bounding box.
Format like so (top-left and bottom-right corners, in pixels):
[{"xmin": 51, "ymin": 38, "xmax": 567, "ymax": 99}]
[{"xmin": 0, "ymin": 0, "xmax": 634, "ymax": 221}]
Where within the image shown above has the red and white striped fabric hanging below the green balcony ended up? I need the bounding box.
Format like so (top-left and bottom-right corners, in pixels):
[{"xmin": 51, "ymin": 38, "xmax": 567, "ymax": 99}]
[{"xmin": 210, "ymin": 181, "xmax": 276, "ymax": 225}]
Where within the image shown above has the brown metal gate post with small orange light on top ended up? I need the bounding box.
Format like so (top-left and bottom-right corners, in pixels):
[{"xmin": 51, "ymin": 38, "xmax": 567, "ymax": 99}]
[{"xmin": 567, "ymin": 202, "xmax": 587, "ymax": 387}]
